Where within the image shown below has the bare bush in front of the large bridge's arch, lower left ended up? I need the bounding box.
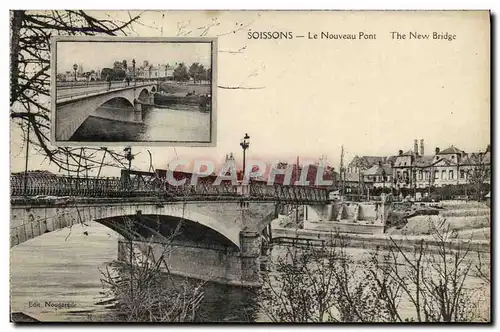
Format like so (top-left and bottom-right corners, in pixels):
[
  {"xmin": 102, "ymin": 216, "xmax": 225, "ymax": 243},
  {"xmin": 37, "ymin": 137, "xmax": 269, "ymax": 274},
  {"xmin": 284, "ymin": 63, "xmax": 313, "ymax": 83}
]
[{"xmin": 97, "ymin": 218, "xmax": 205, "ymax": 323}]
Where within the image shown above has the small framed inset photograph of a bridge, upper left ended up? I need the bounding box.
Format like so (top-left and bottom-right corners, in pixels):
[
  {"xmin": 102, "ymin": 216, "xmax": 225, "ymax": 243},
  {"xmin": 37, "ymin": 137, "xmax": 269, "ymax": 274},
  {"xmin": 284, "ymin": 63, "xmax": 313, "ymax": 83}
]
[{"xmin": 52, "ymin": 37, "xmax": 216, "ymax": 146}]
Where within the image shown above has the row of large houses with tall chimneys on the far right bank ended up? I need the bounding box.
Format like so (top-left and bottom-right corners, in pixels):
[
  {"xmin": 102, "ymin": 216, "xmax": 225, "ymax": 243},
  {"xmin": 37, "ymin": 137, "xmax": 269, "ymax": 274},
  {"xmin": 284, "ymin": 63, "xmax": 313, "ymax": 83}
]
[{"xmin": 344, "ymin": 139, "xmax": 491, "ymax": 194}]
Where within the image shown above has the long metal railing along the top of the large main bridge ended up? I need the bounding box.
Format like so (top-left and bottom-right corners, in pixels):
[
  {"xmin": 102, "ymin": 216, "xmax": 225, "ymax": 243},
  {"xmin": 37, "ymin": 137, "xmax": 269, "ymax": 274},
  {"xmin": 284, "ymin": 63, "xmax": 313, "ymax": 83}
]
[{"xmin": 10, "ymin": 173, "xmax": 328, "ymax": 202}]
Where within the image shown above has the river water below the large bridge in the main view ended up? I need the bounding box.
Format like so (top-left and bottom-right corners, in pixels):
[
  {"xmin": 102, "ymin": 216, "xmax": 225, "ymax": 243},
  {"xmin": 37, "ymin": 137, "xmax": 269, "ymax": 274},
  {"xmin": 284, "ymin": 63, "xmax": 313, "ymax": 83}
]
[{"xmin": 10, "ymin": 222, "xmax": 489, "ymax": 322}]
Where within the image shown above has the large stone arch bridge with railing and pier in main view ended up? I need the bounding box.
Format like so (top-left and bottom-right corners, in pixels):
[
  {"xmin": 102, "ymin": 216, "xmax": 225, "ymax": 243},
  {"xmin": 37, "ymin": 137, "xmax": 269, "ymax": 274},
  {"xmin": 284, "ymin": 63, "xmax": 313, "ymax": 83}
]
[{"xmin": 11, "ymin": 174, "xmax": 329, "ymax": 286}]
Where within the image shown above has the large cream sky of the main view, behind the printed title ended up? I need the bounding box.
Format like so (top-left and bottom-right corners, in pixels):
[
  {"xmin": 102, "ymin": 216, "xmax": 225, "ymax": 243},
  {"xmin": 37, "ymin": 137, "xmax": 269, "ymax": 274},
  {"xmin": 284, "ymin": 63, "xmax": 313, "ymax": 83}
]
[{"xmin": 11, "ymin": 11, "xmax": 490, "ymax": 175}]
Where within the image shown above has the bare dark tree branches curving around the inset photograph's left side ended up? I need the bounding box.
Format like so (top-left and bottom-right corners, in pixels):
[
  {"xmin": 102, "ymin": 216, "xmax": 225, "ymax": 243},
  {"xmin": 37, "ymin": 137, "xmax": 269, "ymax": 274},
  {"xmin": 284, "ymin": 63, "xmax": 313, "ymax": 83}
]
[{"xmin": 10, "ymin": 10, "xmax": 139, "ymax": 173}]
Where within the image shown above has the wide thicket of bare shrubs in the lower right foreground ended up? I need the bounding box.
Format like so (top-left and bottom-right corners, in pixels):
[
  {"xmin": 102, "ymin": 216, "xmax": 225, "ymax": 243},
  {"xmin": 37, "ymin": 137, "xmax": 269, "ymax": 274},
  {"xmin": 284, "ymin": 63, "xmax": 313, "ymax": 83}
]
[{"xmin": 261, "ymin": 220, "xmax": 490, "ymax": 322}]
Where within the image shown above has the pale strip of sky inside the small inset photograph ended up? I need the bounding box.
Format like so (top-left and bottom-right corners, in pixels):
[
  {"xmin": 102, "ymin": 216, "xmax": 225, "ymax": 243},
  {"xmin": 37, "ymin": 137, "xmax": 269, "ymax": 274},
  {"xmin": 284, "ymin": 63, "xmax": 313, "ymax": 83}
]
[{"xmin": 57, "ymin": 41, "xmax": 211, "ymax": 73}]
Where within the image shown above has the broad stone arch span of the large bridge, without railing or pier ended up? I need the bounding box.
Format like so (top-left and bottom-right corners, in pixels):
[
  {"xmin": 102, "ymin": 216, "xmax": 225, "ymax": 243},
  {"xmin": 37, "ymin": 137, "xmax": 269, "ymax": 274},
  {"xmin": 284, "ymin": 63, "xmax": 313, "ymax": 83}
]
[{"xmin": 11, "ymin": 204, "xmax": 241, "ymax": 250}]
